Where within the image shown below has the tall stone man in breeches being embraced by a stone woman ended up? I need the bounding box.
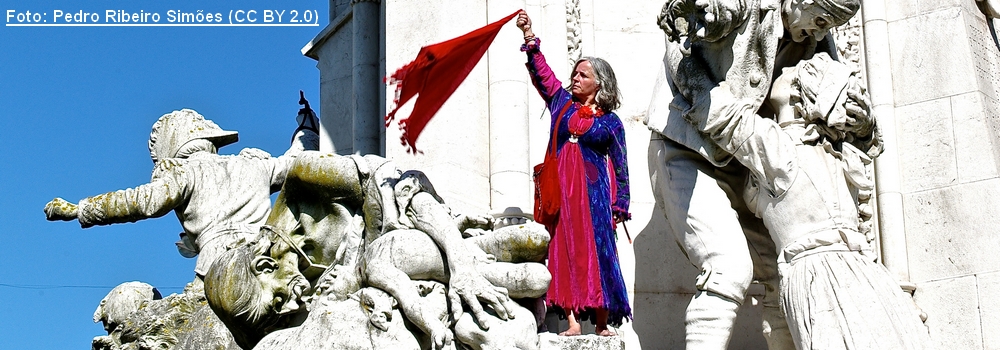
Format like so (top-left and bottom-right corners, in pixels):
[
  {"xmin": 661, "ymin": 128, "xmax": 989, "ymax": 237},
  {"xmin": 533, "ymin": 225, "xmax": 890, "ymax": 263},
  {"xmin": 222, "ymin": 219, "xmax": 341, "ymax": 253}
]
[{"xmin": 646, "ymin": 0, "xmax": 860, "ymax": 349}]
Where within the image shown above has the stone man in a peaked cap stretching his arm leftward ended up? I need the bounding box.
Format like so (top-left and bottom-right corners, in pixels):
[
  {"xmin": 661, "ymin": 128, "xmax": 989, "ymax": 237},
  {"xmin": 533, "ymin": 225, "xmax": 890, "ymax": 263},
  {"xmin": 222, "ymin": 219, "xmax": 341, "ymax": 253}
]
[{"xmin": 45, "ymin": 109, "xmax": 318, "ymax": 280}]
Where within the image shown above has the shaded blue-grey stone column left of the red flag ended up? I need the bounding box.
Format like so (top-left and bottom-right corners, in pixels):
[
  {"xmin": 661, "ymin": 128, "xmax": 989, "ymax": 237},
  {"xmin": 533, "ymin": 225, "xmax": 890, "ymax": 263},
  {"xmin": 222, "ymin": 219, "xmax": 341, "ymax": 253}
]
[{"xmin": 351, "ymin": 0, "xmax": 383, "ymax": 154}]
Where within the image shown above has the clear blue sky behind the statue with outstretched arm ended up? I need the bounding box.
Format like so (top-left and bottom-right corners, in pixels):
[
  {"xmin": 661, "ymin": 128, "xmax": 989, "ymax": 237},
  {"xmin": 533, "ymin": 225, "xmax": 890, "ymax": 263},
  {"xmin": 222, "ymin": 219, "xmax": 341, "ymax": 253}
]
[{"xmin": 0, "ymin": 0, "xmax": 329, "ymax": 349}]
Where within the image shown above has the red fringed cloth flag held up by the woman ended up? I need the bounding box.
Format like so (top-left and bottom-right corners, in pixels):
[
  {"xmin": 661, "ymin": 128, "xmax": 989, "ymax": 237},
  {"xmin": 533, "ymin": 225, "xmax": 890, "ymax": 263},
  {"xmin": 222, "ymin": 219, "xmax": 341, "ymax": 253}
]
[{"xmin": 385, "ymin": 10, "xmax": 521, "ymax": 152}]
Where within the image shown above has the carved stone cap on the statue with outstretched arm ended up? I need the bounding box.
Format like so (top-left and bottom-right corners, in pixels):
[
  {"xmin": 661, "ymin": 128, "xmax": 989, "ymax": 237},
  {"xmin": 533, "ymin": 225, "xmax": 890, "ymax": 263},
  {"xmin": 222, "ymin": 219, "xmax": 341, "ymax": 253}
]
[{"xmin": 149, "ymin": 109, "xmax": 239, "ymax": 164}]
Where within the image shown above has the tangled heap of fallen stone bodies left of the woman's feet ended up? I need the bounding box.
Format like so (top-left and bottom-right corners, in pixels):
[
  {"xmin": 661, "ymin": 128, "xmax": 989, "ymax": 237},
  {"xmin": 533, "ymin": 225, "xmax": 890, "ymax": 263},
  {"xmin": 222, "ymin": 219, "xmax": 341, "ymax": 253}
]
[{"xmin": 199, "ymin": 152, "xmax": 549, "ymax": 349}]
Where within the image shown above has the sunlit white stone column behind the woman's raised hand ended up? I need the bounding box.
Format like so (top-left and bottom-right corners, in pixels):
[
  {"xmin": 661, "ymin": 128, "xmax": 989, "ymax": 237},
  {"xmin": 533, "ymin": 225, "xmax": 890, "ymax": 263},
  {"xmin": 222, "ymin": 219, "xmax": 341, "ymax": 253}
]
[{"xmin": 486, "ymin": 0, "xmax": 533, "ymax": 212}]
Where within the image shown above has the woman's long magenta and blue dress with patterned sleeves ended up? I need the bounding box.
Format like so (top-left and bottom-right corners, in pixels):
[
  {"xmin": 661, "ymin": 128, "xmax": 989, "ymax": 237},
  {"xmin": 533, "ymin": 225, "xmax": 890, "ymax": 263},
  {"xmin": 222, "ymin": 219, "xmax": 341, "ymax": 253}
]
[{"xmin": 522, "ymin": 39, "xmax": 632, "ymax": 326}]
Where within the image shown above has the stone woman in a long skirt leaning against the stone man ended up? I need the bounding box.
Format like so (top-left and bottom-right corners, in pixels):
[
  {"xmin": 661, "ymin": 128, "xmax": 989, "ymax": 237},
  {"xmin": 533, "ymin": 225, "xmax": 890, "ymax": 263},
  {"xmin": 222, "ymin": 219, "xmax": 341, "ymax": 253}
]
[{"xmin": 691, "ymin": 53, "xmax": 929, "ymax": 349}]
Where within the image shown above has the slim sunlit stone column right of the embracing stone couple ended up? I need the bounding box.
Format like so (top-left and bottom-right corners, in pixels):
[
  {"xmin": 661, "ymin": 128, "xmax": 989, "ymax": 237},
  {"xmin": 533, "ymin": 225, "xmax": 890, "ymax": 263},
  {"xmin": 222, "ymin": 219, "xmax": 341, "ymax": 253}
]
[{"xmin": 861, "ymin": 0, "xmax": 916, "ymax": 293}]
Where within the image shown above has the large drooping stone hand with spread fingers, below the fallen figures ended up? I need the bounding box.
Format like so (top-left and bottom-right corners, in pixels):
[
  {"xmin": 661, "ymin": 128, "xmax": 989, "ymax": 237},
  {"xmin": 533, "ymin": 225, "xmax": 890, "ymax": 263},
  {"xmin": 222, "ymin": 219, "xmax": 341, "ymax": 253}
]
[{"xmin": 450, "ymin": 270, "xmax": 514, "ymax": 330}]
